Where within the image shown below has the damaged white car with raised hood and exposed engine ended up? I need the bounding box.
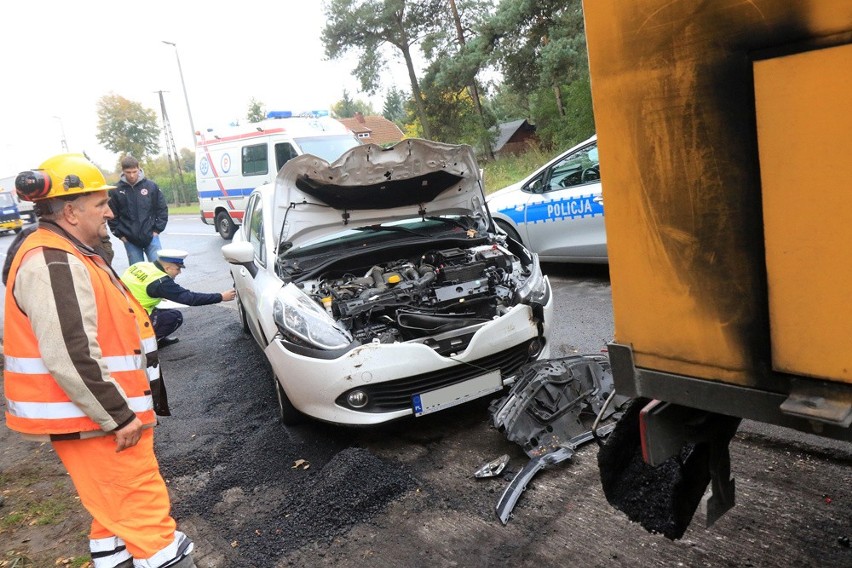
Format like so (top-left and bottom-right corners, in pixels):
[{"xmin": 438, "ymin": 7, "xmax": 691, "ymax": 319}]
[{"xmin": 222, "ymin": 139, "xmax": 553, "ymax": 425}]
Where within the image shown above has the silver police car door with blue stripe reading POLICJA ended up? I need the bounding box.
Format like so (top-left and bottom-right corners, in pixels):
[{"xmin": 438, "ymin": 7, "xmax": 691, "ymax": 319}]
[{"xmin": 523, "ymin": 141, "xmax": 606, "ymax": 261}]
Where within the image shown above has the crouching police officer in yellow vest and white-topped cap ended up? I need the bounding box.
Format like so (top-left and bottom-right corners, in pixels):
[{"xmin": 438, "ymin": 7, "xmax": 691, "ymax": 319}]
[{"xmin": 121, "ymin": 249, "xmax": 236, "ymax": 348}]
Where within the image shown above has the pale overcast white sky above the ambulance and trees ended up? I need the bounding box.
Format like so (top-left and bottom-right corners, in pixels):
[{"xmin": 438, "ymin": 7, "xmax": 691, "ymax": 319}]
[{"xmin": 0, "ymin": 0, "xmax": 408, "ymax": 178}]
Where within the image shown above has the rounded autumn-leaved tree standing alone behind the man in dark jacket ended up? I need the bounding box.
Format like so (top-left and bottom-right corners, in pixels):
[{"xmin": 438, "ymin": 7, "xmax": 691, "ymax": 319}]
[{"xmin": 96, "ymin": 94, "xmax": 160, "ymax": 161}]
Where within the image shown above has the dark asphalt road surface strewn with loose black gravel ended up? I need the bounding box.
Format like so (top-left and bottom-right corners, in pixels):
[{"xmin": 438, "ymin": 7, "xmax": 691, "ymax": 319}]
[{"xmin": 0, "ymin": 217, "xmax": 852, "ymax": 568}]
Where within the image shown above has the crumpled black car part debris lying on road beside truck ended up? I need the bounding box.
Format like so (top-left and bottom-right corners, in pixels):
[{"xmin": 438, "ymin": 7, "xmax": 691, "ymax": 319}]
[{"xmin": 489, "ymin": 355, "xmax": 628, "ymax": 525}]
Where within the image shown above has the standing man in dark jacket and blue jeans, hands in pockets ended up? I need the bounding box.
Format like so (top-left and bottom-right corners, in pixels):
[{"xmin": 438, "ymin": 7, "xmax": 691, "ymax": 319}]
[{"xmin": 109, "ymin": 156, "xmax": 169, "ymax": 264}]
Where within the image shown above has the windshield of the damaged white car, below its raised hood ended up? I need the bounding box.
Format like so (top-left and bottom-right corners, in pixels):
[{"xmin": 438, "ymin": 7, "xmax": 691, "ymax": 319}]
[{"xmin": 285, "ymin": 215, "xmax": 479, "ymax": 259}]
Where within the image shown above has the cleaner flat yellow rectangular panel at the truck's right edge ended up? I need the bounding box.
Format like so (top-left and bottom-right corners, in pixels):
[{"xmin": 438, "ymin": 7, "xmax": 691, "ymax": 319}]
[{"xmin": 754, "ymin": 45, "xmax": 852, "ymax": 382}]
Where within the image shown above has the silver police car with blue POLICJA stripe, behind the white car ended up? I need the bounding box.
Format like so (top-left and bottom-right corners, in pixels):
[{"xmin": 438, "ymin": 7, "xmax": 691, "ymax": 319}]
[{"xmin": 488, "ymin": 136, "xmax": 607, "ymax": 263}]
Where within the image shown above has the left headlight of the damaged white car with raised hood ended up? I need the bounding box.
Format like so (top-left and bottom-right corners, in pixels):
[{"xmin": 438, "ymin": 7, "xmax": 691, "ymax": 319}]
[{"xmin": 272, "ymin": 283, "xmax": 352, "ymax": 349}]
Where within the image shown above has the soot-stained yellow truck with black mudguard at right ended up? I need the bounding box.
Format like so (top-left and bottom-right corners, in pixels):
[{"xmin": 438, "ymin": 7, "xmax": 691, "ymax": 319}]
[{"xmin": 584, "ymin": 0, "xmax": 852, "ymax": 538}]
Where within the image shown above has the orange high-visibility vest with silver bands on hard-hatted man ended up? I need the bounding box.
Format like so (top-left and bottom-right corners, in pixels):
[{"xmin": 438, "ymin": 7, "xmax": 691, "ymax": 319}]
[{"xmin": 4, "ymin": 228, "xmax": 156, "ymax": 435}]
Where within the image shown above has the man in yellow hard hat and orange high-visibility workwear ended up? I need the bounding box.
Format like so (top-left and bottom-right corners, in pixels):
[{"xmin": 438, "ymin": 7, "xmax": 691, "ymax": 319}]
[{"xmin": 3, "ymin": 154, "xmax": 195, "ymax": 568}]
